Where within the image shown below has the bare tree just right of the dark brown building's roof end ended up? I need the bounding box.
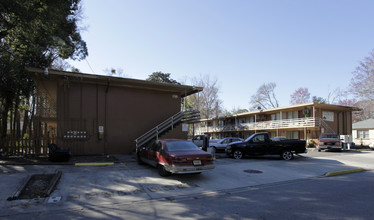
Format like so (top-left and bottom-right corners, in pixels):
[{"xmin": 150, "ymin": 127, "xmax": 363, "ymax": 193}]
[{"xmin": 186, "ymin": 75, "xmax": 222, "ymax": 118}]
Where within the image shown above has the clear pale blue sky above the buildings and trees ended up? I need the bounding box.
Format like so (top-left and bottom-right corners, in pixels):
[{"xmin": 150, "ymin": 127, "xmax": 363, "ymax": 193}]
[{"xmin": 70, "ymin": 0, "xmax": 374, "ymax": 110}]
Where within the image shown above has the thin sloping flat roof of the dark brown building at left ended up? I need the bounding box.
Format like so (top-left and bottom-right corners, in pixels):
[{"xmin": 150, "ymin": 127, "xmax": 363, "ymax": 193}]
[{"xmin": 26, "ymin": 67, "xmax": 203, "ymax": 97}]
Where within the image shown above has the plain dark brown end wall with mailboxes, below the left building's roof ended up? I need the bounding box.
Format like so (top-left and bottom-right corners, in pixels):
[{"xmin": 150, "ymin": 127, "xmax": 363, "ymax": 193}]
[{"xmin": 57, "ymin": 82, "xmax": 187, "ymax": 155}]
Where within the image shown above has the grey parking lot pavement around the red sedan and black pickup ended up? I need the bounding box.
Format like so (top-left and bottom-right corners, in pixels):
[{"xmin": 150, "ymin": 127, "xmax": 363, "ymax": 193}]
[{"xmin": 0, "ymin": 151, "xmax": 374, "ymax": 218}]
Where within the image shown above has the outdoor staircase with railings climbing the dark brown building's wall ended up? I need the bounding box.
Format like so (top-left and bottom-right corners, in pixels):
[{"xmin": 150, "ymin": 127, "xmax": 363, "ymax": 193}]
[{"xmin": 135, "ymin": 111, "xmax": 200, "ymax": 148}]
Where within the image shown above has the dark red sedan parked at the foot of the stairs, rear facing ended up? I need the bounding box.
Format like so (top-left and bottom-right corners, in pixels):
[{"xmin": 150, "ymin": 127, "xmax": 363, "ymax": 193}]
[{"xmin": 137, "ymin": 139, "xmax": 215, "ymax": 176}]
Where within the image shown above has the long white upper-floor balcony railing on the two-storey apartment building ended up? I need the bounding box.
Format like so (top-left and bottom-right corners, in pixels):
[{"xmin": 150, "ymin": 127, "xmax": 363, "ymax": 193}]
[{"xmin": 198, "ymin": 117, "xmax": 321, "ymax": 133}]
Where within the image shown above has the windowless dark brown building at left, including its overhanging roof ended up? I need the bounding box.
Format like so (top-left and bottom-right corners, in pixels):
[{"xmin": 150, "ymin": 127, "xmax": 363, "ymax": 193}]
[{"xmin": 28, "ymin": 68, "xmax": 202, "ymax": 155}]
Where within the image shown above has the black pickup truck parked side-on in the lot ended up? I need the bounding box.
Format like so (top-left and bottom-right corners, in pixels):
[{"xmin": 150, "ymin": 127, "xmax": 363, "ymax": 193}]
[{"xmin": 226, "ymin": 133, "xmax": 307, "ymax": 160}]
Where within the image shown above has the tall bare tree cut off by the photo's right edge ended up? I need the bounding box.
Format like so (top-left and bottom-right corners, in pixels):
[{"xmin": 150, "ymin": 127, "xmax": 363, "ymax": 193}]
[{"xmin": 350, "ymin": 50, "xmax": 374, "ymax": 100}]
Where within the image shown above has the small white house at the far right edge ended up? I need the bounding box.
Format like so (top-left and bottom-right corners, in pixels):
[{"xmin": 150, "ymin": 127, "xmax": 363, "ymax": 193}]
[{"xmin": 352, "ymin": 118, "xmax": 374, "ymax": 148}]
